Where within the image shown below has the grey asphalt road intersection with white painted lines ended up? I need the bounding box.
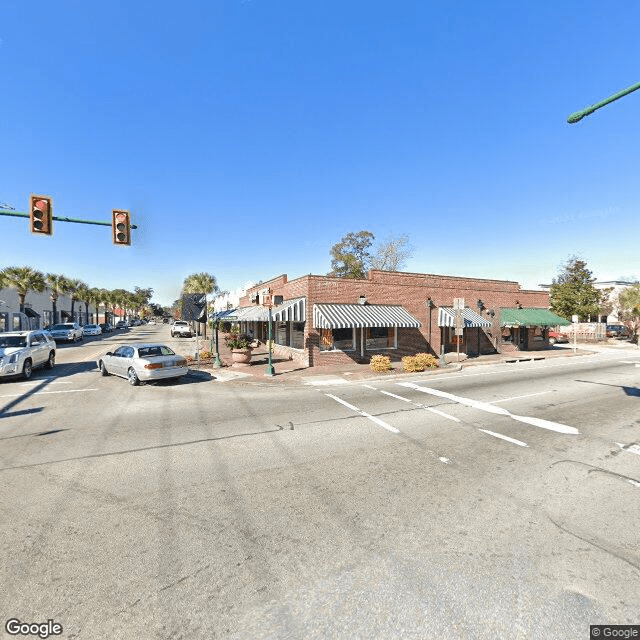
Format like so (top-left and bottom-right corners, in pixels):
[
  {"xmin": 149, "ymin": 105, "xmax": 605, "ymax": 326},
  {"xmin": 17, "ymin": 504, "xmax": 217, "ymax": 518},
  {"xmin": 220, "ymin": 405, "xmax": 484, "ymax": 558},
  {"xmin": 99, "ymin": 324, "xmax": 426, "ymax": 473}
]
[{"xmin": 0, "ymin": 325, "xmax": 640, "ymax": 640}]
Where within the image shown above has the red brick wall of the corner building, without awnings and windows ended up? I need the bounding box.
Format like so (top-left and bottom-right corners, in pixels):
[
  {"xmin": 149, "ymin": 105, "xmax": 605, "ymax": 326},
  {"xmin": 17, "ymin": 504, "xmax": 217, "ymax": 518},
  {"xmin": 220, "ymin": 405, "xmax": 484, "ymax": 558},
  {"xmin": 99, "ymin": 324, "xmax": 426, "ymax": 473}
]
[{"xmin": 235, "ymin": 270, "xmax": 549, "ymax": 366}]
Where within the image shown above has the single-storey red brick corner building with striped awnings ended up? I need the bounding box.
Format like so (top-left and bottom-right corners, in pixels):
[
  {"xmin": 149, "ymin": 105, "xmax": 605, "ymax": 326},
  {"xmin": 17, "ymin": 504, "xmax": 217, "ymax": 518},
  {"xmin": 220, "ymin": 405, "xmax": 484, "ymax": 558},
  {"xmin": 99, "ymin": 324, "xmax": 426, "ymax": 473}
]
[{"xmin": 212, "ymin": 270, "xmax": 557, "ymax": 366}]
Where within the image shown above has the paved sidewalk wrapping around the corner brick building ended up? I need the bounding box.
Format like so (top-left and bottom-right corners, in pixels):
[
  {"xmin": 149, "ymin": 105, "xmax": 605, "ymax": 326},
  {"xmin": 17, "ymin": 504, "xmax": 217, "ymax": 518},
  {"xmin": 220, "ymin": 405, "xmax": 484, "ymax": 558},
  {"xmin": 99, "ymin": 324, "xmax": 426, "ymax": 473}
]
[{"xmin": 190, "ymin": 341, "xmax": 596, "ymax": 386}]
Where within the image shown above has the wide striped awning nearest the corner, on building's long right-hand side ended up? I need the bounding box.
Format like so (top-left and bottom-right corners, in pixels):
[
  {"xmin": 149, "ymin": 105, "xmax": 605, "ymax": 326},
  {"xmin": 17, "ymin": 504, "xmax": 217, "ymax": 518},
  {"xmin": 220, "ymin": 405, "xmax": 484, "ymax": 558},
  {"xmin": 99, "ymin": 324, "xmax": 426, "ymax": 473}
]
[{"xmin": 313, "ymin": 304, "xmax": 421, "ymax": 329}]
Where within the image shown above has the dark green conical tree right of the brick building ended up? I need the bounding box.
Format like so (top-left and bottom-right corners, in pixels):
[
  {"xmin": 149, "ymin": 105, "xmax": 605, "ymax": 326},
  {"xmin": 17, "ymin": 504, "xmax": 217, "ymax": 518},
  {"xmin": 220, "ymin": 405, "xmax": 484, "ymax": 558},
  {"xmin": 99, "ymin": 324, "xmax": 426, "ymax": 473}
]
[{"xmin": 551, "ymin": 256, "xmax": 604, "ymax": 320}]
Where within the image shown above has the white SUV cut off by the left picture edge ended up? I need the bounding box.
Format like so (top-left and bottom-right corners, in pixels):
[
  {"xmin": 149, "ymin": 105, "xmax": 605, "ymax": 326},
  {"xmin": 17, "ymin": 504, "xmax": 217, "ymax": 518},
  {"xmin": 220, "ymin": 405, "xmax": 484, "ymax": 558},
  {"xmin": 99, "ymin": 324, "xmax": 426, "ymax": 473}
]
[{"xmin": 0, "ymin": 331, "xmax": 56, "ymax": 380}]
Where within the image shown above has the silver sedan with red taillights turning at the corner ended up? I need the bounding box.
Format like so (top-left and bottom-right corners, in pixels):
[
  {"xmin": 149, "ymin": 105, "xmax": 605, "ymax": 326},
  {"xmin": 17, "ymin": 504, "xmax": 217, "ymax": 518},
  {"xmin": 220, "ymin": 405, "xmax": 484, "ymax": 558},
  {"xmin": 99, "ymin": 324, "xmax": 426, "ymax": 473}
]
[{"xmin": 97, "ymin": 344, "xmax": 189, "ymax": 386}]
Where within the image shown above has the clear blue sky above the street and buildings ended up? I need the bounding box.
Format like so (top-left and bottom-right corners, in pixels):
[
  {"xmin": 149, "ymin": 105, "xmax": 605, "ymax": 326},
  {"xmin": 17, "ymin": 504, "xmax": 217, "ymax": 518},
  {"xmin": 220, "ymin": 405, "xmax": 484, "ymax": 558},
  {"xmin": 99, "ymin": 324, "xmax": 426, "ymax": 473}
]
[{"xmin": 0, "ymin": 0, "xmax": 640, "ymax": 304}]
